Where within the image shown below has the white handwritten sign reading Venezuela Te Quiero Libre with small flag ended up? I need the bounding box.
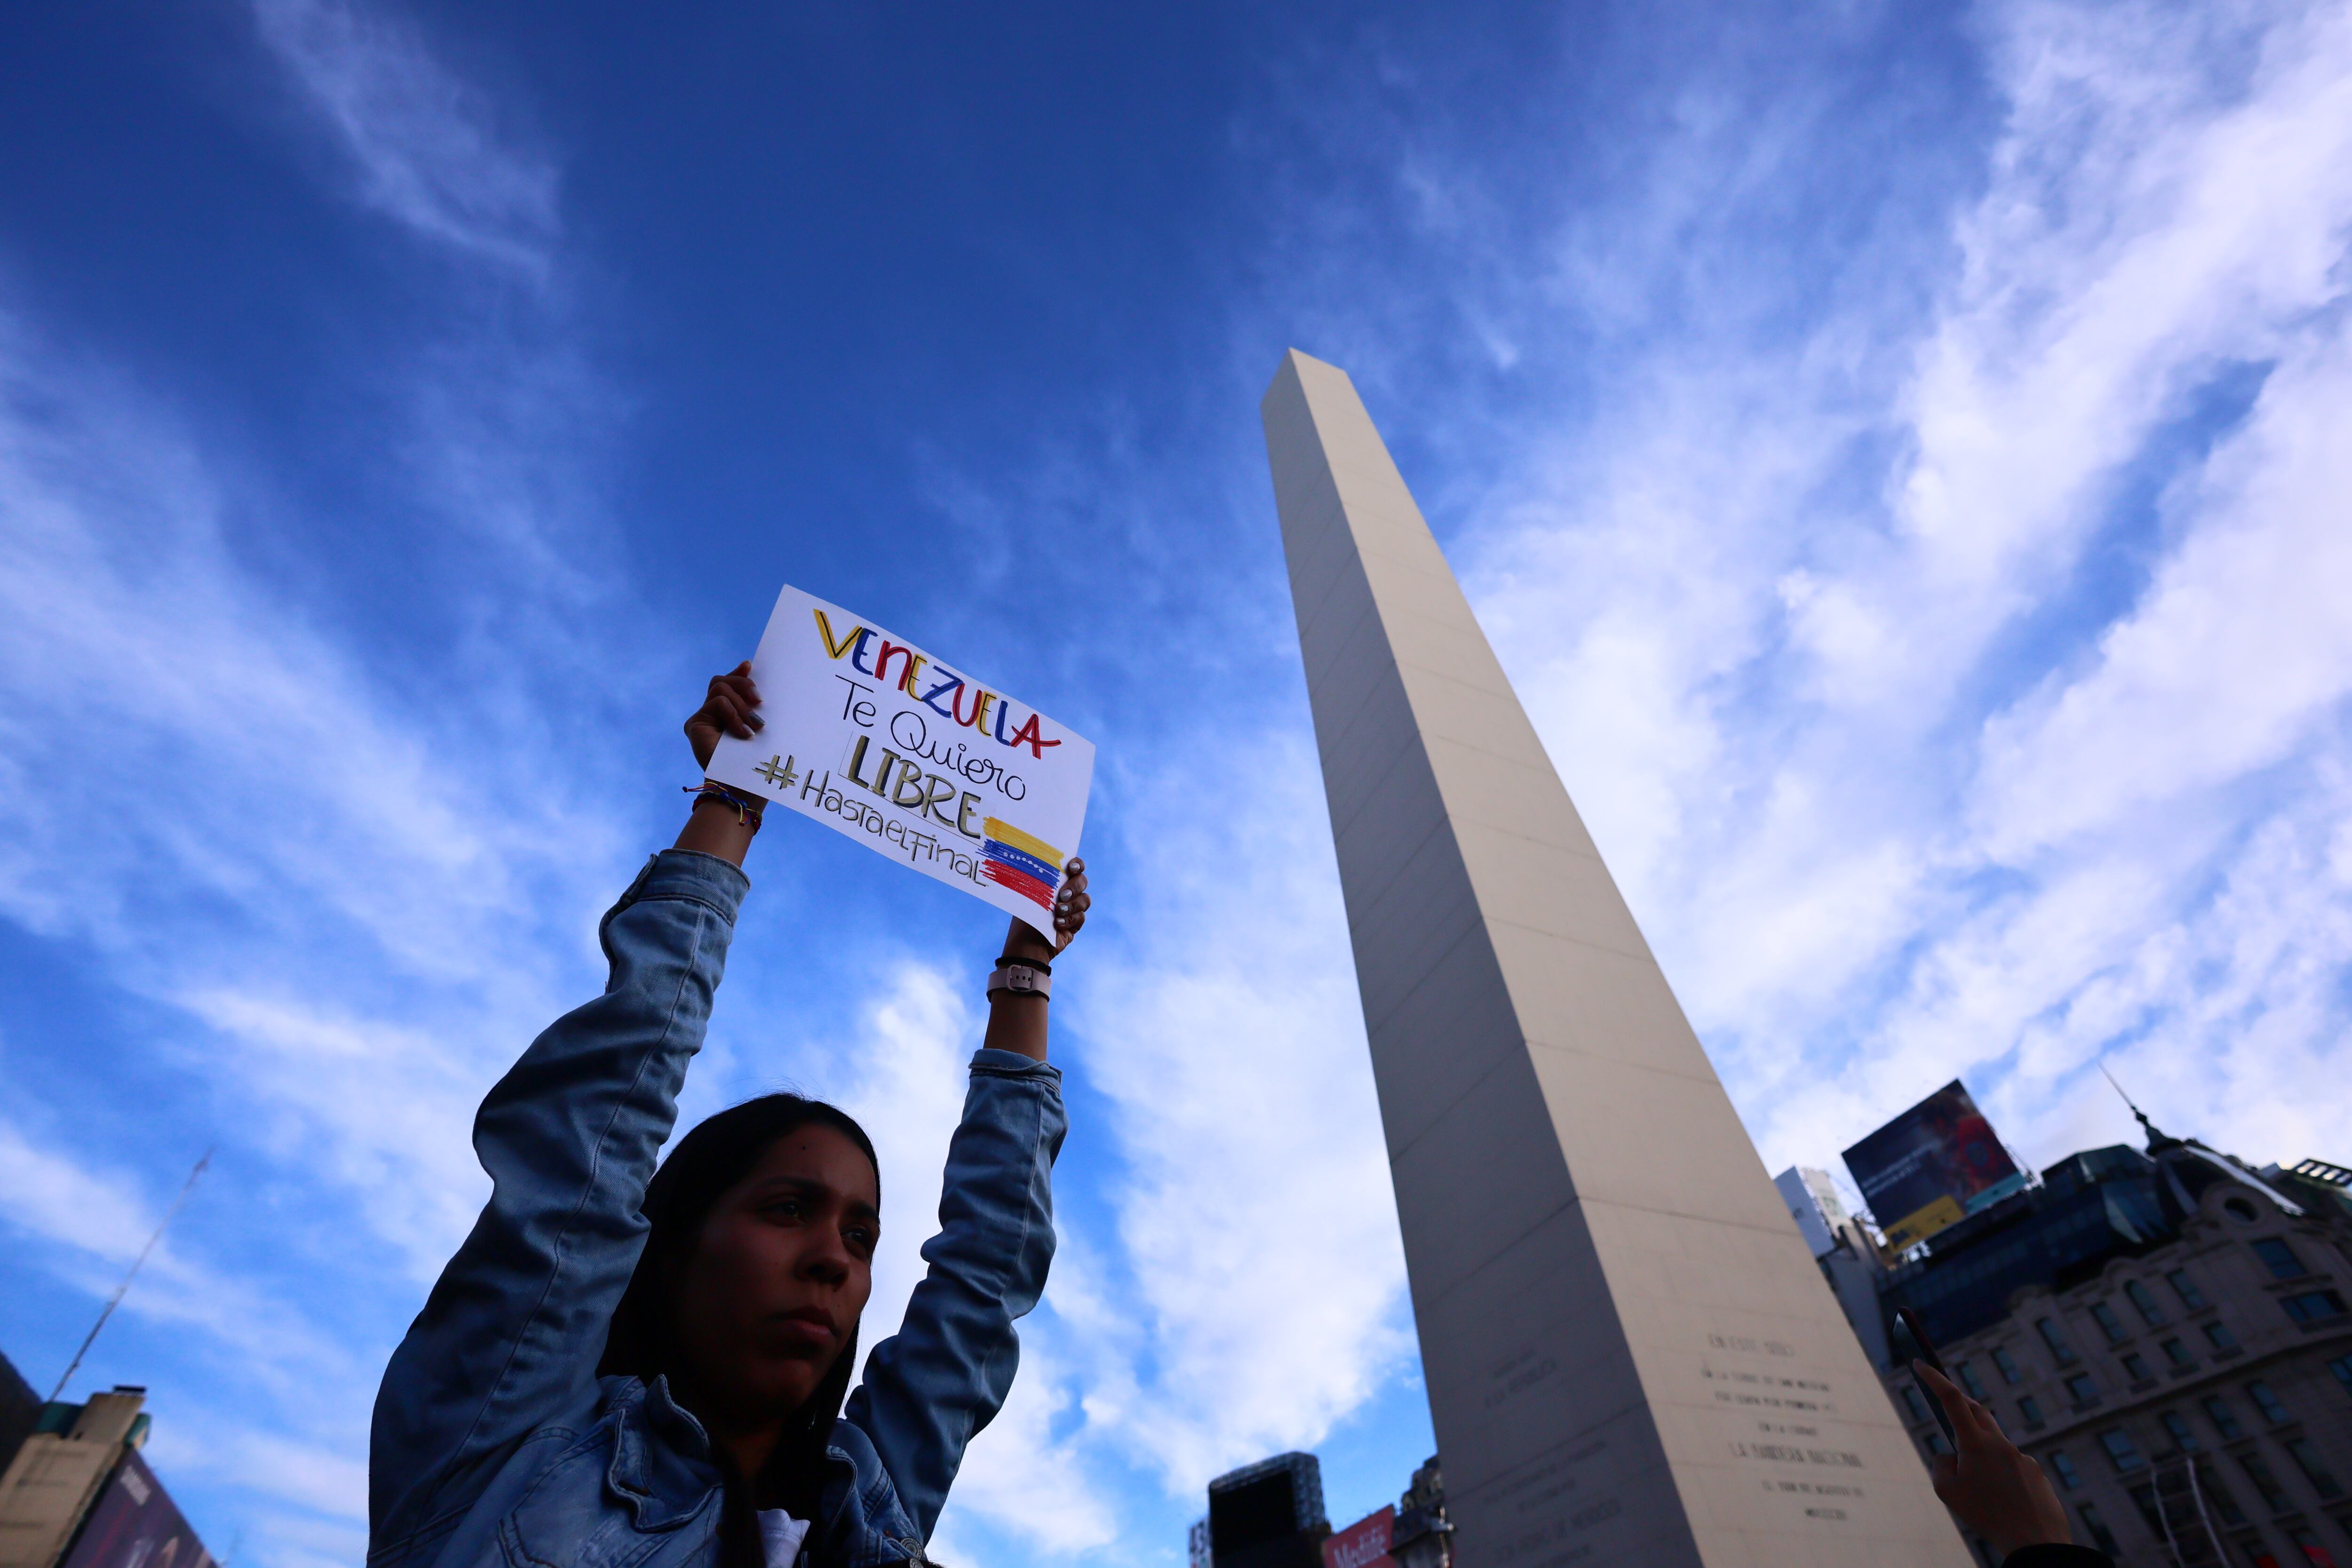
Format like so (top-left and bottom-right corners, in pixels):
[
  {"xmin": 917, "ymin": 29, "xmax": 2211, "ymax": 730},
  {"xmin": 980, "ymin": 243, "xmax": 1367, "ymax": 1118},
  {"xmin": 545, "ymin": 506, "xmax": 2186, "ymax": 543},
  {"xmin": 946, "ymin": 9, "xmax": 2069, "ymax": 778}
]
[{"xmin": 708, "ymin": 588, "xmax": 1094, "ymax": 936}]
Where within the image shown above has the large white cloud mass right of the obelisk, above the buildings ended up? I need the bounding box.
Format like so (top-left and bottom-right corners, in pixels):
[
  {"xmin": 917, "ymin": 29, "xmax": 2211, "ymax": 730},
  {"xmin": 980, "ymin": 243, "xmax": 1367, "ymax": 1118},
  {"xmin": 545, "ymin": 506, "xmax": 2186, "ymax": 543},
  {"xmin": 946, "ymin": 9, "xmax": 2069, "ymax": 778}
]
[{"xmin": 1465, "ymin": 2, "xmax": 2352, "ymax": 1185}]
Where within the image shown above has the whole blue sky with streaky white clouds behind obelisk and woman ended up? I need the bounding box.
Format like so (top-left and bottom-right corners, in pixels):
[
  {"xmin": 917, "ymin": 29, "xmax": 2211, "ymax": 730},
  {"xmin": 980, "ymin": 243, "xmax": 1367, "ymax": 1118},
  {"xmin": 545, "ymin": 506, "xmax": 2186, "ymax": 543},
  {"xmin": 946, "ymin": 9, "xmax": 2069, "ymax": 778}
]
[{"xmin": 0, "ymin": 0, "xmax": 2352, "ymax": 1568}]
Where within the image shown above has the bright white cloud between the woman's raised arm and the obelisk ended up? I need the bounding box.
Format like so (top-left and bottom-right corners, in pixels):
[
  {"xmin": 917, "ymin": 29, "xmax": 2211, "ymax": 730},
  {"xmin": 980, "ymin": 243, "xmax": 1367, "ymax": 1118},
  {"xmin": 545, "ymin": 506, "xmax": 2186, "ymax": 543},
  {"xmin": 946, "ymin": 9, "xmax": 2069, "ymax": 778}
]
[{"xmin": 1056, "ymin": 736, "xmax": 1411, "ymax": 1490}]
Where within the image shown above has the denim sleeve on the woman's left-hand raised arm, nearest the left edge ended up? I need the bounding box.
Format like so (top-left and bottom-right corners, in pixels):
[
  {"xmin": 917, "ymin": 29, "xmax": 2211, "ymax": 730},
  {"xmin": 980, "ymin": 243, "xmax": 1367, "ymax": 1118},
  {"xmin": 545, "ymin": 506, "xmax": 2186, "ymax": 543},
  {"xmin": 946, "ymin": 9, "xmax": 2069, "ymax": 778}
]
[{"xmin": 367, "ymin": 849, "xmax": 750, "ymax": 1549}]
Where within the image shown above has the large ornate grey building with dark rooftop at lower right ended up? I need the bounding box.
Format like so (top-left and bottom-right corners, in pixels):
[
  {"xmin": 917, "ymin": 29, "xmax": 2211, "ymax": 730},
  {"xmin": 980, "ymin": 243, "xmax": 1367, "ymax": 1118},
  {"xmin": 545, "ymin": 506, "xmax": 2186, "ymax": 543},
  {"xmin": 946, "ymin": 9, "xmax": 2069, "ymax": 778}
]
[{"xmin": 1780, "ymin": 1117, "xmax": 2352, "ymax": 1568}]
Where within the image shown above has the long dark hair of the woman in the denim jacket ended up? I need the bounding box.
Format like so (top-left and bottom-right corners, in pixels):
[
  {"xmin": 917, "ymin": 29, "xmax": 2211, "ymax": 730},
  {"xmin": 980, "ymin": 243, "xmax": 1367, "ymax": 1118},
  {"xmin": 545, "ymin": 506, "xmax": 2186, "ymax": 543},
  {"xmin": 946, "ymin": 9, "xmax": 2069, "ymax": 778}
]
[{"xmin": 597, "ymin": 1093, "xmax": 882, "ymax": 1568}]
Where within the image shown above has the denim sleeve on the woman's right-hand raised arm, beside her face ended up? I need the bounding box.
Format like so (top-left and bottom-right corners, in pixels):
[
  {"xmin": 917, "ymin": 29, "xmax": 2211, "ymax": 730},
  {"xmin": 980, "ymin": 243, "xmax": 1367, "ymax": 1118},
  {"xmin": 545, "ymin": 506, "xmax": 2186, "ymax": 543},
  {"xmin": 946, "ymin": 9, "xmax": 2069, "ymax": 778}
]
[{"xmin": 844, "ymin": 1051, "xmax": 1070, "ymax": 1540}]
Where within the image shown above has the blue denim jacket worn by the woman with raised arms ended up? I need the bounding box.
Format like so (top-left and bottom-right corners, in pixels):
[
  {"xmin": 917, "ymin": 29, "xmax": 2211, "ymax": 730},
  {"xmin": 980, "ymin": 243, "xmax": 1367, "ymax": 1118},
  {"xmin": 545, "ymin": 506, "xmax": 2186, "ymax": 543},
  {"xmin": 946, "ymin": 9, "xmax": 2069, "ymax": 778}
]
[{"xmin": 367, "ymin": 849, "xmax": 1068, "ymax": 1568}]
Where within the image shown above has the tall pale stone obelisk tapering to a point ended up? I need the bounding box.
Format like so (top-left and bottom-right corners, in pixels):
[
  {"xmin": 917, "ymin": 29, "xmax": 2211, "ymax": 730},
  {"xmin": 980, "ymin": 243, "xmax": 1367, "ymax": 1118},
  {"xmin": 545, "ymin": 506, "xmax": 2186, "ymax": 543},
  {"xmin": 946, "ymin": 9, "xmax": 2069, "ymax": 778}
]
[{"xmin": 1261, "ymin": 350, "xmax": 1971, "ymax": 1568}]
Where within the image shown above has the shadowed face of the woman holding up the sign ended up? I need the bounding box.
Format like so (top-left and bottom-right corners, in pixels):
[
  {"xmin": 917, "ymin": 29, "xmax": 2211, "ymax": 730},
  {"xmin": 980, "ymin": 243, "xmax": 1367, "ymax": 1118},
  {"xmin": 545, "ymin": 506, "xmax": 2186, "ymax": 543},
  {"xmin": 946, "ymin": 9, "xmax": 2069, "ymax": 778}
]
[{"xmin": 673, "ymin": 1124, "xmax": 882, "ymax": 1427}]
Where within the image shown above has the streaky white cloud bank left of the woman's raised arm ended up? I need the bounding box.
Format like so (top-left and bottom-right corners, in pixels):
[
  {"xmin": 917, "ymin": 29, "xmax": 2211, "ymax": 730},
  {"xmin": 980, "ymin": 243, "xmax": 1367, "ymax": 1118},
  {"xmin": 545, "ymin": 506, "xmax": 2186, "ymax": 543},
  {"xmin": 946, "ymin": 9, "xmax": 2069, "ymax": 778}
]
[{"xmin": 0, "ymin": 294, "xmax": 626, "ymax": 1542}]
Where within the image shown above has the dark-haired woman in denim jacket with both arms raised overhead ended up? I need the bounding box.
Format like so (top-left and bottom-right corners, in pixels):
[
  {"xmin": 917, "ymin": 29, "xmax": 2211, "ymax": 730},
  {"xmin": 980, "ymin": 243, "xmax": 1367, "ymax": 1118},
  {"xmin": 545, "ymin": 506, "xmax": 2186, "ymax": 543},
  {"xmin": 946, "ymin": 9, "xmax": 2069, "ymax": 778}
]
[{"xmin": 369, "ymin": 665, "xmax": 1089, "ymax": 1568}]
